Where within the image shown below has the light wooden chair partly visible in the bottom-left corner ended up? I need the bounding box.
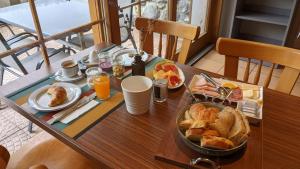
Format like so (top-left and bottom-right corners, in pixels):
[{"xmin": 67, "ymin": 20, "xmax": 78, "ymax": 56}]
[{"xmin": 0, "ymin": 132, "xmax": 99, "ymax": 169}]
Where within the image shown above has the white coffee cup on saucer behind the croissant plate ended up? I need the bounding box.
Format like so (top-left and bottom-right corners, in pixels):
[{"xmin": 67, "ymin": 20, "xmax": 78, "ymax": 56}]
[{"xmin": 61, "ymin": 60, "xmax": 79, "ymax": 77}]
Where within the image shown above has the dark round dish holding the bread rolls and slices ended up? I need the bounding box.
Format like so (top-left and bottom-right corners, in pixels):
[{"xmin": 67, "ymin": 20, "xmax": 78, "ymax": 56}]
[{"xmin": 176, "ymin": 102, "xmax": 247, "ymax": 157}]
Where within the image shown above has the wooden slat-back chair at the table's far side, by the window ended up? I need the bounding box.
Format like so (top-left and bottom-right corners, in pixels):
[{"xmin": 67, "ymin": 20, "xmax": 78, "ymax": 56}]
[{"xmin": 135, "ymin": 17, "xmax": 200, "ymax": 64}]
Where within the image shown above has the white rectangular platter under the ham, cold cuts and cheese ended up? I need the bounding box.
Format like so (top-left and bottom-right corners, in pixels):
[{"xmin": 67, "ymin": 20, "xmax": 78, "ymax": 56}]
[{"xmin": 189, "ymin": 75, "xmax": 263, "ymax": 123}]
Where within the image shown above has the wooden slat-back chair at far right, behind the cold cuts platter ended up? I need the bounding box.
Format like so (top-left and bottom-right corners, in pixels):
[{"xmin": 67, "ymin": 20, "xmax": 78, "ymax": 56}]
[{"xmin": 216, "ymin": 38, "xmax": 300, "ymax": 94}]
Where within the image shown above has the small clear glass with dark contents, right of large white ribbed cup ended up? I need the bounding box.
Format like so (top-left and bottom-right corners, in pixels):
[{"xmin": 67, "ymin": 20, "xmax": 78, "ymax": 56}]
[{"xmin": 153, "ymin": 79, "xmax": 168, "ymax": 102}]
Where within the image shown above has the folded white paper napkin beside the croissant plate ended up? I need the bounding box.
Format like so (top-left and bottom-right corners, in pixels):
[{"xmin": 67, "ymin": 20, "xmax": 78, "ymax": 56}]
[{"xmin": 60, "ymin": 100, "xmax": 99, "ymax": 124}]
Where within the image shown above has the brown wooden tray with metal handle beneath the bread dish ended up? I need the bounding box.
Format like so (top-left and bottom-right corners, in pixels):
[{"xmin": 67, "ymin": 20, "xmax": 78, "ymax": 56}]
[{"xmin": 155, "ymin": 92, "xmax": 262, "ymax": 169}]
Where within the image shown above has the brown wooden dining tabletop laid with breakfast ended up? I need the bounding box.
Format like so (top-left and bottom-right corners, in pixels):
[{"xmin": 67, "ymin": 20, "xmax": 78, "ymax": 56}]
[{"xmin": 0, "ymin": 43, "xmax": 300, "ymax": 169}]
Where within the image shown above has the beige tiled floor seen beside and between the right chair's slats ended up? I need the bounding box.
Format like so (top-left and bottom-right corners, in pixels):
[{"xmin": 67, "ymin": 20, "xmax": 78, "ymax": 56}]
[{"xmin": 194, "ymin": 50, "xmax": 300, "ymax": 97}]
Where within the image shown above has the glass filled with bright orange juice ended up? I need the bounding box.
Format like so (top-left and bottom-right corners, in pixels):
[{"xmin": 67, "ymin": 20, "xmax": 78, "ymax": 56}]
[{"xmin": 94, "ymin": 72, "xmax": 110, "ymax": 100}]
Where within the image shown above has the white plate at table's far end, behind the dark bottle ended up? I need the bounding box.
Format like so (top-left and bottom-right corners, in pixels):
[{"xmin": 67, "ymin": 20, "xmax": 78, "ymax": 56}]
[{"xmin": 113, "ymin": 49, "xmax": 149, "ymax": 66}]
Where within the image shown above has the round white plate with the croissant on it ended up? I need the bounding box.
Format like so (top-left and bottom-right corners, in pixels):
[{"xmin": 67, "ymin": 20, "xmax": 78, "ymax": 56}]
[{"xmin": 28, "ymin": 82, "xmax": 81, "ymax": 112}]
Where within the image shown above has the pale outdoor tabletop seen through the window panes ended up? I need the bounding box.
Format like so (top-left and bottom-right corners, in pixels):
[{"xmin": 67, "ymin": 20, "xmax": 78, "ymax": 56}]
[{"xmin": 0, "ymin": 0, "xmax": 90, "ymax": 36}]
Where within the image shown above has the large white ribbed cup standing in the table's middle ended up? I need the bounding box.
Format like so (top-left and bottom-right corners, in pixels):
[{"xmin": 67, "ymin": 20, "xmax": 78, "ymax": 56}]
[{"xmin": 121, "ymin": 76, "xmax": 153, "ymax": 115}]
